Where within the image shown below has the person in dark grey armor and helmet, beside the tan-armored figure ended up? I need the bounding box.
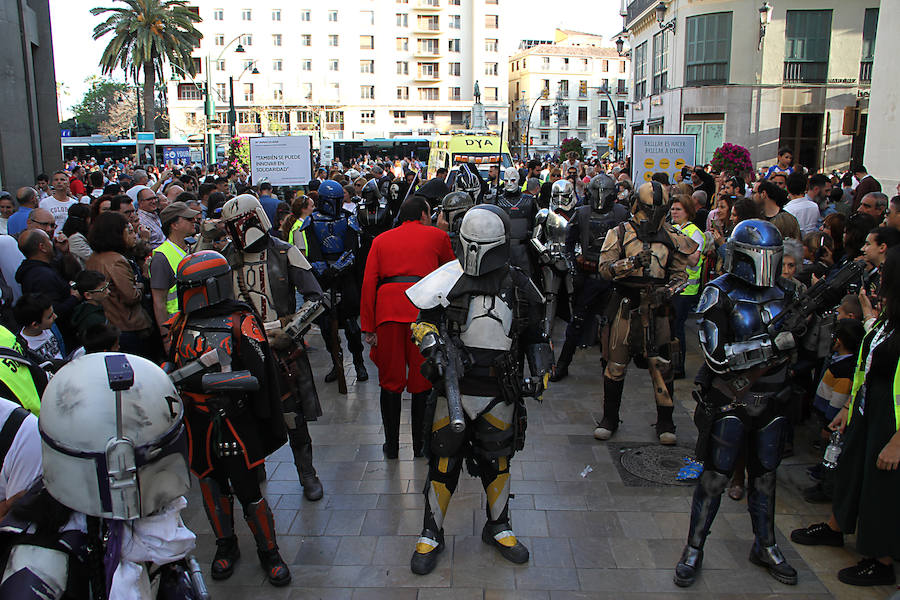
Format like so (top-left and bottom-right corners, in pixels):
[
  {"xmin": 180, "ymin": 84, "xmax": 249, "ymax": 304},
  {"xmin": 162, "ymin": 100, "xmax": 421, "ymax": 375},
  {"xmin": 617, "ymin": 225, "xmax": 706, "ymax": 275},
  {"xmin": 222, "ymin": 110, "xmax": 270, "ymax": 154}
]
[{"xmin": 550, "ymin": 173, "xmax": 628, "ymax": 381}]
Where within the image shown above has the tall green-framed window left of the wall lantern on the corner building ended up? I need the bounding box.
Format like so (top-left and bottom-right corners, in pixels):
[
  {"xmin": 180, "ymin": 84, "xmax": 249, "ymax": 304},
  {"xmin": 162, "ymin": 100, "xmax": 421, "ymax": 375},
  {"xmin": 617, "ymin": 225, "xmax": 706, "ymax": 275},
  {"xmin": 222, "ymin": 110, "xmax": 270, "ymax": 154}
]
[{"xmin": 684, "ymin": 12, "xmax": 731, "ymax": 85}]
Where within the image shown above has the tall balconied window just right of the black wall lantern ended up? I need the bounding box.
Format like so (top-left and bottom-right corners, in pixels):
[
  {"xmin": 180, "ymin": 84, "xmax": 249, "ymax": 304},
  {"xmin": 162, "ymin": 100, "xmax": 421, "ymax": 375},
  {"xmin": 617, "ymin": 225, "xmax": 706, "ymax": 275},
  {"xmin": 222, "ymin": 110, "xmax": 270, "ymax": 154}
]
[{"xmin": 784, "ymin": 10, "xmax": 831, "ymax": 83}]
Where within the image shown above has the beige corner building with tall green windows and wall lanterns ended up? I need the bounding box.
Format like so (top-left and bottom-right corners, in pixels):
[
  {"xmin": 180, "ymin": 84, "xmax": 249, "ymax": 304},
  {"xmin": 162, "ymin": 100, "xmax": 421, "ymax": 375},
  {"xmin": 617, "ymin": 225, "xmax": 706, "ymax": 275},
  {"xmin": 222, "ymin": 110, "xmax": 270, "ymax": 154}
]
[{"xmin": 623, "ymin": 0, "xmax": 879, "ymax": 171}]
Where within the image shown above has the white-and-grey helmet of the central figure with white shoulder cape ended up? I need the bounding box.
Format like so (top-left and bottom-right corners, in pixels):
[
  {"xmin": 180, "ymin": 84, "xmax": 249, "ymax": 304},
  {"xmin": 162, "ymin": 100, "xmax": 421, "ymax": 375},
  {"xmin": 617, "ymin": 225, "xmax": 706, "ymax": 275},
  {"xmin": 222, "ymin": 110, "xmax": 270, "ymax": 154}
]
[{"xmin": 459, "ymin": 204, "xmax": 509, "ymax": 276}]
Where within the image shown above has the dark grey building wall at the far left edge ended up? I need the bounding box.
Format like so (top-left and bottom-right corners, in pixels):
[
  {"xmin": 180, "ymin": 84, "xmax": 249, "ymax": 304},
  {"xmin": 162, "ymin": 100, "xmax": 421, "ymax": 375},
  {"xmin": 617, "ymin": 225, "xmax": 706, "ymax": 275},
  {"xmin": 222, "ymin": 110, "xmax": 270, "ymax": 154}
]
[{"xmin": 0, "ymin": 0, "xmax": 62, "ymax": 192}]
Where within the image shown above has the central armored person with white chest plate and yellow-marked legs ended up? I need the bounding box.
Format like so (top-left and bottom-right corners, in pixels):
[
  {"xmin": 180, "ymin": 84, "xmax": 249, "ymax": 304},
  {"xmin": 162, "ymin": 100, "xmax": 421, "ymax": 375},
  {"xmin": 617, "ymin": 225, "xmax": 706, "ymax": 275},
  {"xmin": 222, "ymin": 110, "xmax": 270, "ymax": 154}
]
[{"xmin": 406, "ymin": 204, "xmax": 553, "ymax": 575}]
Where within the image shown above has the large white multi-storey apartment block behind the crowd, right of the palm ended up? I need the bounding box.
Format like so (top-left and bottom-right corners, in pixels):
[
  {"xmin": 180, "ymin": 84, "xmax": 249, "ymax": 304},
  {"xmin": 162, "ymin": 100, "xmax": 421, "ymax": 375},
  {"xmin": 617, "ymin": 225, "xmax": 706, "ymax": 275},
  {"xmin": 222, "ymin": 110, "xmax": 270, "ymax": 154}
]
[{"xmin": 168, "ymin": 0, "xmax": 507, "ymax": 145}]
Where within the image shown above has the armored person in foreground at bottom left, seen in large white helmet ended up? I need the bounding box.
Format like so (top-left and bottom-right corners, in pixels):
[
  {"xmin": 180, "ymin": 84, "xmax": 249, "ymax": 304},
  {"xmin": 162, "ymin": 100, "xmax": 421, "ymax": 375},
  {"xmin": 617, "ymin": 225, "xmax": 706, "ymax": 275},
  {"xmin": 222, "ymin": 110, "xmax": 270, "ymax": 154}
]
[{"xmin": 0, "ymin": 353, "xmax": 199, "ymax": 600}]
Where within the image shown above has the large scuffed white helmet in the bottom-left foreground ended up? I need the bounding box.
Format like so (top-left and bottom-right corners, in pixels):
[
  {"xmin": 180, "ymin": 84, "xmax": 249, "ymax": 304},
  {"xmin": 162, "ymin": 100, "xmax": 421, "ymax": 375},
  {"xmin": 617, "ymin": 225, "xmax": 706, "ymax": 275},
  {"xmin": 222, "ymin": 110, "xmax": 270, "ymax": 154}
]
[{"xmin": 38, "ymin": 352, "xmax": 191, "ymax": 520}]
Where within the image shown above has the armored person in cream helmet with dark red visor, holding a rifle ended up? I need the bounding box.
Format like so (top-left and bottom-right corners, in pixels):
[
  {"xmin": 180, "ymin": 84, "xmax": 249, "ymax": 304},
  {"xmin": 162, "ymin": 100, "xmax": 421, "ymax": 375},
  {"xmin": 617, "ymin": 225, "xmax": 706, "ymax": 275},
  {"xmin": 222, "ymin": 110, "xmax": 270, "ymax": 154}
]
[{"xmin": 222, "ymin": 194, "xmax": 324, "ymax": 501}]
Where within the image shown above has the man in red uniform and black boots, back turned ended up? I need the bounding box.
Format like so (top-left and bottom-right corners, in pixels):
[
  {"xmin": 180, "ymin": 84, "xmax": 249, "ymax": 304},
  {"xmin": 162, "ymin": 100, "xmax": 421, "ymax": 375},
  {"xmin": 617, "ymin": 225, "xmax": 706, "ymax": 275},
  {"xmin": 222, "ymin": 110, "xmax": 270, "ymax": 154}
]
[{"xmin": 360, "ymin": 196, "xmax": 456, "ymax": 458}]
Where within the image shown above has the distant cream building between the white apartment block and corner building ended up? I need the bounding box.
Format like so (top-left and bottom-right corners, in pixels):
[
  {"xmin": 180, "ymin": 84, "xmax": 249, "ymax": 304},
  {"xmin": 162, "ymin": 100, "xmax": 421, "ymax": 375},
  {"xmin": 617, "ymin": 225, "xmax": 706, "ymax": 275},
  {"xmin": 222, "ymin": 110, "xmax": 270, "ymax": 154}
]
[{"xmin": 508, "ymin": 29, "xmax": 630, "ymax": 156}]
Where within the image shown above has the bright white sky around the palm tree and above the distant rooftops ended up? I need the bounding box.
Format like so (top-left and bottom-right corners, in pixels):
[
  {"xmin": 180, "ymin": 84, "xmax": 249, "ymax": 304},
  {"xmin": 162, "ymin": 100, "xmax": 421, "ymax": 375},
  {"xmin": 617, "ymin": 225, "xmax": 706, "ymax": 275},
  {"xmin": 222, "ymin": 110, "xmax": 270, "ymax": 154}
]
[{"xmin": 50, "ymin": 0, "xmax": 622, "ymax": 119}]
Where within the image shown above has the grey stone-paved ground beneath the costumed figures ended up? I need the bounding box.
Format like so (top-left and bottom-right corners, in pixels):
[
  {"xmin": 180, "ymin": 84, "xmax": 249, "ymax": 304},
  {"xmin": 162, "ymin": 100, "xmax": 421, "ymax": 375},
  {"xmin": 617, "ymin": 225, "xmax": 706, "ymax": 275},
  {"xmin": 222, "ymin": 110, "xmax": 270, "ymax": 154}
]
[{"xmin": 179, "ymin": 325, "xmax": 894, "ymax": 600}]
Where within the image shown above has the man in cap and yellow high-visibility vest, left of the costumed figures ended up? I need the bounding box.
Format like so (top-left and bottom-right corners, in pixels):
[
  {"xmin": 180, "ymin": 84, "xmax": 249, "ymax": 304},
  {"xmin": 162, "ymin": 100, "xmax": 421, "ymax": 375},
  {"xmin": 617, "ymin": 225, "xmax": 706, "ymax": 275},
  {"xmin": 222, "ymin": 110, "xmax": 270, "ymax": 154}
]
[{"xmin": 150, "ymin": 202, "xmax": 200, "ymax": 352}]
